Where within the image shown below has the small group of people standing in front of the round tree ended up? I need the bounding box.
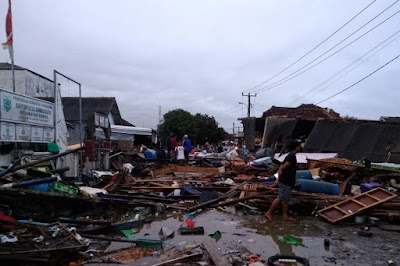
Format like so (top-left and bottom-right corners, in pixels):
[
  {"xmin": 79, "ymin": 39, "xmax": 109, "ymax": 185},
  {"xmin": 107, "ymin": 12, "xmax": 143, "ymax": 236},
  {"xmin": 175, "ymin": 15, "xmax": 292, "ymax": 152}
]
[{"xmin": 165, "ymin": 132, "xmax": 192, "ymax": 162}]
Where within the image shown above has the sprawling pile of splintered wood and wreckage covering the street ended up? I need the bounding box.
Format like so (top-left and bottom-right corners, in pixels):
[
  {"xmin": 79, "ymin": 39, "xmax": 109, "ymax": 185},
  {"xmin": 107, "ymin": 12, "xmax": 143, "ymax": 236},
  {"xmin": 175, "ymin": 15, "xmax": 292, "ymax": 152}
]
[{"xmin": 0, "ymin": 150, "xmax": 400, "ymax": 265}]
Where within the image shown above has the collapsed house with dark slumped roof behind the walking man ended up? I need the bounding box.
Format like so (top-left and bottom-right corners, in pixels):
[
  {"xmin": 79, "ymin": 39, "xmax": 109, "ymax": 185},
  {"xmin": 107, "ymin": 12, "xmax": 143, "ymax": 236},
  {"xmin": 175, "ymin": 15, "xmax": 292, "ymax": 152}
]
[{"xmin": 242, "ymin": 104, "xmax": 400, "ymax": 163}]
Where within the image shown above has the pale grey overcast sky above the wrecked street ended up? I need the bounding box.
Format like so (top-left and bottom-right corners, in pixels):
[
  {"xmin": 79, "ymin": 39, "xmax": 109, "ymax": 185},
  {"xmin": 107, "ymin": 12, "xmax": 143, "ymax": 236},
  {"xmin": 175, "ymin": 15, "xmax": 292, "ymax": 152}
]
[{"xmin": 0, "ymin": 0, "xmax": 400, "ymax": 132}]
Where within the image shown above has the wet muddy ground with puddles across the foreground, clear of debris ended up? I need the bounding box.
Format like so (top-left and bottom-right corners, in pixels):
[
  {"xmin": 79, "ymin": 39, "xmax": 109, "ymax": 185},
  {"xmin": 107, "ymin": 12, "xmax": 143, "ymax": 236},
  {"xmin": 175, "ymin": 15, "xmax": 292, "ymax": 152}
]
[{"xmin": 97, "ymin": 208, "xmax": 400, "ymax": 265}]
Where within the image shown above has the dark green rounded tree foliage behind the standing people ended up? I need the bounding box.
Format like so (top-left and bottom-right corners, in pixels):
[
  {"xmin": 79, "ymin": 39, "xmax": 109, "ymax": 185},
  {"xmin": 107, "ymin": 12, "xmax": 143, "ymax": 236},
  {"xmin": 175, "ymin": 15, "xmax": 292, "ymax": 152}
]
[{"xmin": 158, "ymin": 109, "xmax": 227, "ymax": 144}]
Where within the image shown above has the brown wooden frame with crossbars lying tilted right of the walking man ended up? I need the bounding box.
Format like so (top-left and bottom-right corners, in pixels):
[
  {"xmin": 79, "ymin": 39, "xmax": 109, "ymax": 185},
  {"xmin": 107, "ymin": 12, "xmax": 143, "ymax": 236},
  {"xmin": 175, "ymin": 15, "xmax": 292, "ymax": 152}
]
[{"xmin": 318, "ymin": 188, "xmax": 397, "ymax": 223}]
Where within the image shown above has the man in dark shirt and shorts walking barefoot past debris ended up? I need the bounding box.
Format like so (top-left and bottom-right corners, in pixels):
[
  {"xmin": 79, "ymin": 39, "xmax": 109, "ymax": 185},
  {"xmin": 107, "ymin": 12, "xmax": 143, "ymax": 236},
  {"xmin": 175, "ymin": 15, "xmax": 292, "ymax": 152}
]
[{"xmin": 265, "ymin": 141, "xmax": 300, "ymax": 222}]
